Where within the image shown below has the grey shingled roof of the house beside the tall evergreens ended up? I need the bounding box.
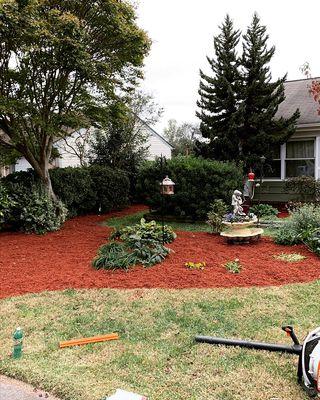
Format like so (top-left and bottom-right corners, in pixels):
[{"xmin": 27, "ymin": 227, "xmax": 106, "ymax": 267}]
[{"xmin": 276, "ymin": 78, "xmax": 320, "ymax": 125}]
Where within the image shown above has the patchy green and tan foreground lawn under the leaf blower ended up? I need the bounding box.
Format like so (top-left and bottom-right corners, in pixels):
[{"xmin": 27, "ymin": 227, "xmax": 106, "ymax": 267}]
[{"xmin": 0, "ymin": 281, "xmax": 320, "ymax": 400}]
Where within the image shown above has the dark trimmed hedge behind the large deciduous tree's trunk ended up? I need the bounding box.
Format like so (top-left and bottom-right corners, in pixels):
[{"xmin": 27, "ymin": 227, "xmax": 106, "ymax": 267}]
[{"xmin": 2, "ymin": 165, "xmax": 130, "ymax": 216}]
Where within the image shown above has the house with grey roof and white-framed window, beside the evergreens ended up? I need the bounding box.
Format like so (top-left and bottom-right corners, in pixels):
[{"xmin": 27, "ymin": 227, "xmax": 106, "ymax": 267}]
[{"xmin": 261, "ymin": 78, "xmax": 320, "ymax": 202}]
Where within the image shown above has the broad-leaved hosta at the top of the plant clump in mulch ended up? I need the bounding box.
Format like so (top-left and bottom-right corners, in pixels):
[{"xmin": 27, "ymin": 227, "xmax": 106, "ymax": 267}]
[{"xmin": 111, "ymin": 218, "xmax": 177, "ymax": 243}]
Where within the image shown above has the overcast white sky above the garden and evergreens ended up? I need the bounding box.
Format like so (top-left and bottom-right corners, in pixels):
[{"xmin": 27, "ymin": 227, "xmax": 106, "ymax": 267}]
[{"xmin": 138, "ymin": 0, "xmax": 320, "ymax": 133}]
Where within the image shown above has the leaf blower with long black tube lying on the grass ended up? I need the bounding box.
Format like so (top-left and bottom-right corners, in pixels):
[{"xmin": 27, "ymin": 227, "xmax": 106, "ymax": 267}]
[{"xmin": 195, "ymin": 326, "xmax": 320, "ymax": 397}]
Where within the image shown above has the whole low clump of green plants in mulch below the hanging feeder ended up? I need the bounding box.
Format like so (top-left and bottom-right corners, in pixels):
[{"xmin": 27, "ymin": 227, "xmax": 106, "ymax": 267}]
[{"xmin": 92, "ymin": 219, "xmax": 176, "ymax": 270}]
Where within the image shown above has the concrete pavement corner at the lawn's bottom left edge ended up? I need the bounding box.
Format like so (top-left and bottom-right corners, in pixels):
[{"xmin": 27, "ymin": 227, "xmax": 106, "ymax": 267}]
[{"xmin": 0, "ymin": 375, "xmax": 59, "ymax": 400}]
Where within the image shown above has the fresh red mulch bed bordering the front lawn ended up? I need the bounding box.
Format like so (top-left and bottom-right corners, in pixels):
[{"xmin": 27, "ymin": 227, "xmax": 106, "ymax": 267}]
[{"xmin": 0, "ymin": 206, "xmax": 320, "ymax": 298}]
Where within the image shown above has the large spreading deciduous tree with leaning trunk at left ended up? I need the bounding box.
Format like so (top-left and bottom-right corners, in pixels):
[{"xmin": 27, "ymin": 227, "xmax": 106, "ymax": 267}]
[{"xmin": 0, "ymin": 0, "xmax": 150, "ymax": 198}]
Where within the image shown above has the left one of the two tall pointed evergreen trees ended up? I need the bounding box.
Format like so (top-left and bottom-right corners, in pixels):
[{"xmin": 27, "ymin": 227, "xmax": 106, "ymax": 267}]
[{"xmin": 197, "ymin": 15, "xmax": 240, "ymax": 160}]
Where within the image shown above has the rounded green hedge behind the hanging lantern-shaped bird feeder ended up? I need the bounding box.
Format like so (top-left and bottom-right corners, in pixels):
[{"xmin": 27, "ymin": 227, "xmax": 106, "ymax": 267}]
[{"xmin": 136, "ymin": 156, "xmax": 243, "ymax": 220}]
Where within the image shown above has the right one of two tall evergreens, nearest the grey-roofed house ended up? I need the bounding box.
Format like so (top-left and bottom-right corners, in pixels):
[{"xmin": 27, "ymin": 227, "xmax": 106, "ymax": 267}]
[{"xmin": 238, "ymin": 14, "xmax": 299, "ymax": 167}]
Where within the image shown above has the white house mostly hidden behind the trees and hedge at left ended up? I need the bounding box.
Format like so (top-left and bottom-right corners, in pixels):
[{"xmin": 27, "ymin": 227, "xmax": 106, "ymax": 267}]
[{"xmin": 8, "ymin": 120, "xmax": 173, "ymax": 175}]
